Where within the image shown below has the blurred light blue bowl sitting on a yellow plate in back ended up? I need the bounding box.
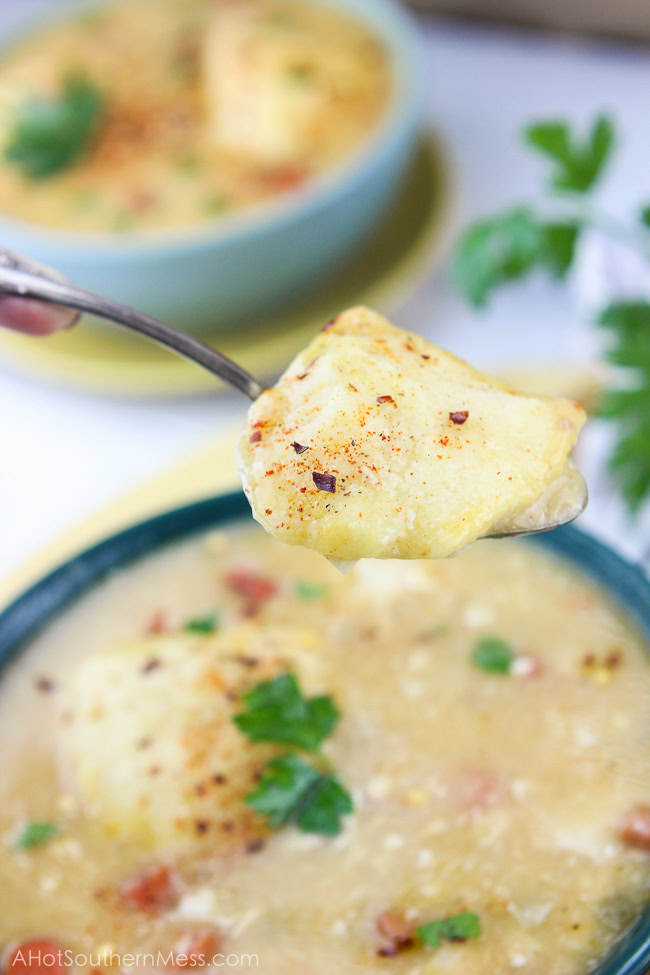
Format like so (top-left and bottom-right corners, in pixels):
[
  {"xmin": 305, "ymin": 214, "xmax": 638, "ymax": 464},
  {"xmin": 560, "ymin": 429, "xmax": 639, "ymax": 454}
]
[{"xmin": 0, "ymin": 0, "xmax": 421, "ymax": 331}]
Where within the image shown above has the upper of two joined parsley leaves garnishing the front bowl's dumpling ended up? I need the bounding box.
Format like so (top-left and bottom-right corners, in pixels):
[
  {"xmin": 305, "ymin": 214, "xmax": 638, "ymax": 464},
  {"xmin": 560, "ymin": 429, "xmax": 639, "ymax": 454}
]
[{"xmin": 233, "ymin": 674, "xmax": 339, "ymax": 751}]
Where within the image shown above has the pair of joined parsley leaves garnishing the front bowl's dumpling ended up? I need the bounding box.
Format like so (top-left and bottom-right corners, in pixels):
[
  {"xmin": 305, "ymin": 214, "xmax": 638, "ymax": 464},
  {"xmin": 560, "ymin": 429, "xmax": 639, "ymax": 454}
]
[{"xmin": 233, "ymin": 674, "xmax": 353, "ymax": 836}]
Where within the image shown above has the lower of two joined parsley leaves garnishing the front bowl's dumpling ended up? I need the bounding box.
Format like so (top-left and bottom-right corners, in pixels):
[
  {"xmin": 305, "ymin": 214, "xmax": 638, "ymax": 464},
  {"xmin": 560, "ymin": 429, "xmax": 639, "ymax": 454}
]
[{"xmin": 245, "ymin": 752, "xmax": 352, "ymax": 836}]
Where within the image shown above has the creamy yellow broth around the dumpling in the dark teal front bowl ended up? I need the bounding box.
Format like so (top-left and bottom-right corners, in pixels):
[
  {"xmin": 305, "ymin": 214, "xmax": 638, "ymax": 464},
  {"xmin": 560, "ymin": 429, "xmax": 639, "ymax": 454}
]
[{"xmin": 0, "ymin": 528, "xmax": 650, "ymax": 975}]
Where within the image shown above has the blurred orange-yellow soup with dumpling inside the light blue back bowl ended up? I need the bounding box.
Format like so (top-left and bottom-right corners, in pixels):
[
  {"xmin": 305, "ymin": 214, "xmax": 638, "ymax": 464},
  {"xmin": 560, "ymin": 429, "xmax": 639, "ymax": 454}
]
[{"xmin": 0, "ymin": 0, "xmax": 390, "ymax": 232}]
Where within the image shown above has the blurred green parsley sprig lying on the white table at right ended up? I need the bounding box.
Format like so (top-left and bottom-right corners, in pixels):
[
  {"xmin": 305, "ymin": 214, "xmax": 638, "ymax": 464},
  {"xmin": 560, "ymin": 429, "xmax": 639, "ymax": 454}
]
[{"xmin": 451, "ymin": 116, "xmax": 650, "ymax": 511}]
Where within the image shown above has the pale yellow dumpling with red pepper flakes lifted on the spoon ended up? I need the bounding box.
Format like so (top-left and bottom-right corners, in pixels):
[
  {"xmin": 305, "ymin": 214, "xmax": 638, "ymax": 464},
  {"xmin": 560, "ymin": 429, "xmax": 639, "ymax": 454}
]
[{"xmin": 237, "ymin": 308, "xmax": 585, "ymax": 562}]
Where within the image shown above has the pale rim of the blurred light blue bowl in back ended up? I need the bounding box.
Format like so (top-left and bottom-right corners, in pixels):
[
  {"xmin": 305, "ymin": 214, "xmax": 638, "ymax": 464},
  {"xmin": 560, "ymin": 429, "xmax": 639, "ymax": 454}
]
[{"xmin": 0, "ymin": 0, "xmax": 423, "ymax": 255}]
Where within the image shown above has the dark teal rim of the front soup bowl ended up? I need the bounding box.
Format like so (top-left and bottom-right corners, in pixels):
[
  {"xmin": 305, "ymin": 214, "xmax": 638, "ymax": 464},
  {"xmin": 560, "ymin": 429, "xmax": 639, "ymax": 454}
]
[{"xmin": 0, "ymin": 491, "xmax": 650, "ymax": 975}]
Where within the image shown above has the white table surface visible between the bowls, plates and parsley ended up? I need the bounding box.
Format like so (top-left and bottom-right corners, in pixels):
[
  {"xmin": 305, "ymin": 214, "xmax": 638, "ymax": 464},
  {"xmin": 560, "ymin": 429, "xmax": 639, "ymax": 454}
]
[{"xmin": 0, "ymin": 9, "xmax": 650, "ymax": 575}]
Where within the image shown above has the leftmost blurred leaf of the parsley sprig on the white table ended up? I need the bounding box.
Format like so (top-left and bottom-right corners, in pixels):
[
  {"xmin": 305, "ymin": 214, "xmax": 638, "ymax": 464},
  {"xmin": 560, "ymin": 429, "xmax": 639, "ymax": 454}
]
[{"xmin": 451, "ymin": 207, "xmax": 544, "ymax": 307}]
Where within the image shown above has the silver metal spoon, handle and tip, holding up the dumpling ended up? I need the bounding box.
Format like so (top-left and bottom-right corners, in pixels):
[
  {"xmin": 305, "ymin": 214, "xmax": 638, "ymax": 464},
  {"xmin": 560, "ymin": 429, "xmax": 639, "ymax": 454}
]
[{"xmin": 0, "ymin": 250, "xmax": 588, "ymax": 538}]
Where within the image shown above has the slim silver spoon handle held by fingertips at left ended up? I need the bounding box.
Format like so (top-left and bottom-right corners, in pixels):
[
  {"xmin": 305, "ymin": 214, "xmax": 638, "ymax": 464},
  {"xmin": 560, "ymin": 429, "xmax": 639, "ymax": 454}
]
[{"xmin": 0, "ymin": 252, "xmax": 265, "ymax": 400}]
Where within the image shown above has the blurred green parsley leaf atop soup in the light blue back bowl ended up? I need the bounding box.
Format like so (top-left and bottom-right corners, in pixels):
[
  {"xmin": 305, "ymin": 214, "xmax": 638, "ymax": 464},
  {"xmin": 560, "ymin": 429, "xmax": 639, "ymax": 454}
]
[{"xmin": 4, "ymin": 74, "xmax": 104, "ymax": 180}]
